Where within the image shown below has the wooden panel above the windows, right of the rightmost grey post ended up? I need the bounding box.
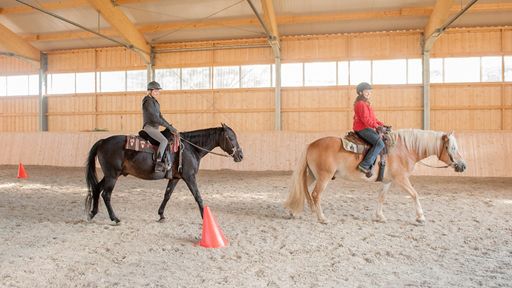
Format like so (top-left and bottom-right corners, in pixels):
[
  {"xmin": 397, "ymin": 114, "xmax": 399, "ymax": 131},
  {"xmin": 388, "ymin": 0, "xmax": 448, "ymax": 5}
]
[{"xmin": 431, "ymin": 28, "xmax": 502, "ymax": 57}]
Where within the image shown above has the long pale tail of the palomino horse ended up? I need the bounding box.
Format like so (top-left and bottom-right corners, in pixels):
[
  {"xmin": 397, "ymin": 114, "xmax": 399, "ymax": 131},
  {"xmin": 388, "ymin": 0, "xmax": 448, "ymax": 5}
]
[{"xmin": 284, "ymin": 148, "xmax": 313, "ymax": 214}]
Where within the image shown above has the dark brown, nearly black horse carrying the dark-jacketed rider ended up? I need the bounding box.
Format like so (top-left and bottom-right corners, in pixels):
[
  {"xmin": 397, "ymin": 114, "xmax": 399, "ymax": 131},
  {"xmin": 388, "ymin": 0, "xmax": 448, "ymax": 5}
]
[{"xmin": 85, "ymin": 124, "xmax": 244, "ymax": 223}]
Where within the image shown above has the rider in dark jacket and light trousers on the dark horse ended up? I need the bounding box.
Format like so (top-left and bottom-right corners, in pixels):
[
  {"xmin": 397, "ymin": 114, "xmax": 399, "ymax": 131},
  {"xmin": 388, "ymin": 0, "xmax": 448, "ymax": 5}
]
[{"xmin": 142, "ymin": 81, "xmax": 178, "ymax": 172}]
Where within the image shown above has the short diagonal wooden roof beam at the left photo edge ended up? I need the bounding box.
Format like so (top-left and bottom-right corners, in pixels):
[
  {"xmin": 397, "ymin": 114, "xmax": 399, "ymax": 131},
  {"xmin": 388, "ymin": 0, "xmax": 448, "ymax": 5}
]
[{"xmin": 0, "ymin": 24, "xmax": 41, "ymax": 63}]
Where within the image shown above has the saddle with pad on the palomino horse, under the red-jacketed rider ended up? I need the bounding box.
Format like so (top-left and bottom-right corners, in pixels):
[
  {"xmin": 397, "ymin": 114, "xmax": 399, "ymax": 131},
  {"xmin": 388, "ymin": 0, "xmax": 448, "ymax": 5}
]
[{"xmin": 341, "ymin": 129, "xmax": 393, "ymax": 182}]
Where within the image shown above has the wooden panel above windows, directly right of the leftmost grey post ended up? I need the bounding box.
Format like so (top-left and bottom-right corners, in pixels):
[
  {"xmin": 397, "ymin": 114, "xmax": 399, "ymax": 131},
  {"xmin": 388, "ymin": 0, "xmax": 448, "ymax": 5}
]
[{"xmin": 48, "ymin": 49, "xmax": 96, "ymax": 73}]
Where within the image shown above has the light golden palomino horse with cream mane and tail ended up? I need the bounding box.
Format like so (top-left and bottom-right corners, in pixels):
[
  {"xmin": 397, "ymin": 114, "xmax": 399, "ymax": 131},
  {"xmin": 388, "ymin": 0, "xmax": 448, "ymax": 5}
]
[{"xmin": 285, "ymin": 129, "xmax": 466, "ymax": 223}]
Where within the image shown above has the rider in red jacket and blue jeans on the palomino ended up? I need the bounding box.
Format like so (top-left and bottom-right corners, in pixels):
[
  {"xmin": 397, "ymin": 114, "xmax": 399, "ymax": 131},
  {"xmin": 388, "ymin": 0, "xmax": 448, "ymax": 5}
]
[{"xmin": 352, "ymin": 82, "xmax": 384, "ymax": 175}]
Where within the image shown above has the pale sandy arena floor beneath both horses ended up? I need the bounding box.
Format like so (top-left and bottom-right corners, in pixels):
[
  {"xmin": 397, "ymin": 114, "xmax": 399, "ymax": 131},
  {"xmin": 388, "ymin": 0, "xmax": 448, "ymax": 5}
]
[{"xmin": 0, "ymin": 166, "xmax": 512, "ymax": 287}]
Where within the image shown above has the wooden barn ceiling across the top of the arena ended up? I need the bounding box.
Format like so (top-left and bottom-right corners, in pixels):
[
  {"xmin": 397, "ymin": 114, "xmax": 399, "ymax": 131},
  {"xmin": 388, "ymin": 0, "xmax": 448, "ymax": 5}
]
[{"xmin": 0, "ymin": 0, "xmax": 512, "ymax": 52}]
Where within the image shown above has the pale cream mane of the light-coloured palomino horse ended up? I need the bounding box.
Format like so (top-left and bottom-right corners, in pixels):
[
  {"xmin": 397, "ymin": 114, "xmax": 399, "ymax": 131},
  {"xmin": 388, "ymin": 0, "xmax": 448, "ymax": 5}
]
[{"xmin": 392, "ymin": 129, "xmax": 443, "ymax": 158}]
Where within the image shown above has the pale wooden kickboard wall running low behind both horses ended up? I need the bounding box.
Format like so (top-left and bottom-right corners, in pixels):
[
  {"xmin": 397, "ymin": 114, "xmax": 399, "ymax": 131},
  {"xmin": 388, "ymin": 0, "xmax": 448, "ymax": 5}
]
[{"xmin": 0, "ymin": 131, "xmax": 512, "ymax": 177}]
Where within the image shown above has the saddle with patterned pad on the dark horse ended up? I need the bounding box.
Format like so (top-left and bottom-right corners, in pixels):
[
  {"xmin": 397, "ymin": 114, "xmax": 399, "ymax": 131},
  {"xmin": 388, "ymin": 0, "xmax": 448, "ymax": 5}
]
[{"xmin": 125, "ymin": 129, "xmax": 183, "ymax": 177}]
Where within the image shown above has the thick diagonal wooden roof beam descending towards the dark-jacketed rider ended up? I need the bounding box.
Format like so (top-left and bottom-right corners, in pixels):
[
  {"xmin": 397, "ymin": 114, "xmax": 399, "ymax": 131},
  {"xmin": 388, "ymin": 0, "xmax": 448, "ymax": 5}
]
[{"xmin": 87, "ymin": 0, "xmax": 151, "ymax": 63}]
